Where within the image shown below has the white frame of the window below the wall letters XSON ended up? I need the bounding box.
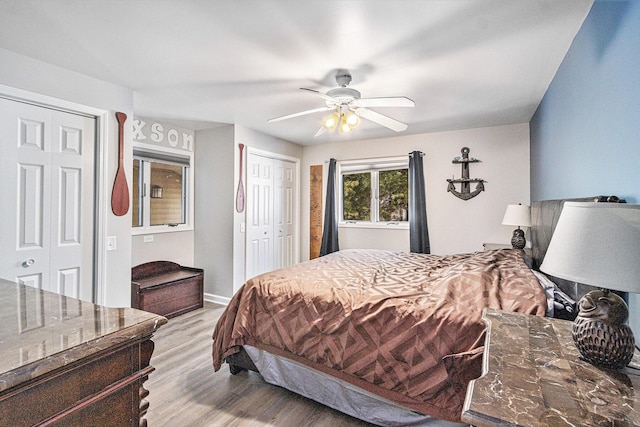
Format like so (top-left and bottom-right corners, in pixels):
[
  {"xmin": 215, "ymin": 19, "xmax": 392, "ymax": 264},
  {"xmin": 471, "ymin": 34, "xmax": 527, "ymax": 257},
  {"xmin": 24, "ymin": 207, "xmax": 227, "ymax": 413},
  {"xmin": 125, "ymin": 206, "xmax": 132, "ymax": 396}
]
[{"xmin": 131, "ymin": 142, "xmax": 194, "ymax": 236}]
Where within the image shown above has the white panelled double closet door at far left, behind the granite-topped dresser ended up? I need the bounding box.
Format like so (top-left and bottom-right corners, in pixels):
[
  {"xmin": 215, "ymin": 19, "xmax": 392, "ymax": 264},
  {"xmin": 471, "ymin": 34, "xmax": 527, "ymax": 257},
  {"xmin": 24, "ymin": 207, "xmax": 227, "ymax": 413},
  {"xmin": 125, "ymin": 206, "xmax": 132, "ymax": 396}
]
[{"xmin": 0, "ymin": 99, "xmax": 96, "ymax": 301}]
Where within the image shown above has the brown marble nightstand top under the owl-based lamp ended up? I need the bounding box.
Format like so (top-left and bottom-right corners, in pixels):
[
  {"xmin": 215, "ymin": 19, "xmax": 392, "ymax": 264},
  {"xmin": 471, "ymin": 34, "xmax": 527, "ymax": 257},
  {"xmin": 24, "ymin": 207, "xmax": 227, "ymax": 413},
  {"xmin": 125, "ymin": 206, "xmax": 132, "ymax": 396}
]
[{"xmin": 462, "ymin": 309, "xmax": 640, "ymax": 427}]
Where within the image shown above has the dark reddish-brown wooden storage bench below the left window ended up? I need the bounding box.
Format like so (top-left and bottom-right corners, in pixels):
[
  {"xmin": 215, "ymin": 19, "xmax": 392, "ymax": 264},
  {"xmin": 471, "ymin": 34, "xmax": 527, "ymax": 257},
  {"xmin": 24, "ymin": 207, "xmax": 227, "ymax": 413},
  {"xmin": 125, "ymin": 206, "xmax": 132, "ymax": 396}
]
[{"xmin": 131, "ymin": 261, "xmax": 204, "ymax": 317}]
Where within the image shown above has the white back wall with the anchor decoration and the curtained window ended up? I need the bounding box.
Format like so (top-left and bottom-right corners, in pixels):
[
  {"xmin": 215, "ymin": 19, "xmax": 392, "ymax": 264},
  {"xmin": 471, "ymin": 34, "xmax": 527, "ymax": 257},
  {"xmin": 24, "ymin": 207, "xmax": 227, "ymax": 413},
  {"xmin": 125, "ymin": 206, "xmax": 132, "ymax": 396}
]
[{"xmin": 300, "ymin": 123, "xmax": 530, "ymax": 260}]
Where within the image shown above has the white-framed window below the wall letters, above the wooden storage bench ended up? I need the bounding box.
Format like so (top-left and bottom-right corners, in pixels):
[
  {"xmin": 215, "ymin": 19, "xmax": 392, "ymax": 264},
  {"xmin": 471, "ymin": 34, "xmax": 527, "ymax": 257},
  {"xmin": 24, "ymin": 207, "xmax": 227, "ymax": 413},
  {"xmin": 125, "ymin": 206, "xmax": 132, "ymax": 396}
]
[{"xmin": 132, "ymin": 147, "xmax": 193, "ymax": 234}]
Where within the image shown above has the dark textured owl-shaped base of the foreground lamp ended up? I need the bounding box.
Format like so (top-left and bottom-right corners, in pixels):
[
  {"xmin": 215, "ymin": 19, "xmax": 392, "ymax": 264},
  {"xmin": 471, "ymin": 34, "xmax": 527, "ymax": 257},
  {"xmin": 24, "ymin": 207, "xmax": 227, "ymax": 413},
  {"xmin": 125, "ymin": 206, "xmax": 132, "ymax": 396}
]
[{"xmin": 572, "ymin": 289, "xmax": 635, "ymax": 369}]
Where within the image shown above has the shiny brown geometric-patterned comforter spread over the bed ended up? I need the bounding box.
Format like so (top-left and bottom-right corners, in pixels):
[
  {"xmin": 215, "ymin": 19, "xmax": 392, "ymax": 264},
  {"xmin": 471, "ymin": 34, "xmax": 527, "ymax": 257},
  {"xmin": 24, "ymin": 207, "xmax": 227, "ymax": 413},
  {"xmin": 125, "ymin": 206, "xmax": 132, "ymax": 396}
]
[{"xmin": 213, "ymin": 250, "xmax": 546, "ymax": 421}]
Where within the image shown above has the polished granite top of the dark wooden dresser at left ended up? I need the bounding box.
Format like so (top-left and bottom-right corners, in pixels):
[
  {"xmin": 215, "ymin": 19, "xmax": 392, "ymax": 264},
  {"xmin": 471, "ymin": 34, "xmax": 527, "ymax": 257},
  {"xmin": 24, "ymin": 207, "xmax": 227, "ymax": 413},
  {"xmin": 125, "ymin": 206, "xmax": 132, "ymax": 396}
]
[{"xmin": 0, "ymin": 279, "xmax": 167, "ymax": 392}]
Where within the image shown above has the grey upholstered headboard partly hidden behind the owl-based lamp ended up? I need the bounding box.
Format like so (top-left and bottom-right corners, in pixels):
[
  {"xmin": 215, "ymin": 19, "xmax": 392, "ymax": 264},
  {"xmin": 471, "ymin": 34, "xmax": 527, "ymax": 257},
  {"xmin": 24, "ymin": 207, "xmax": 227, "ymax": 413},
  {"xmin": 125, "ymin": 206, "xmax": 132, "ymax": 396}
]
[{"xmin": 531, "ymin": 196, "xmax": 624, "ymax": 316}]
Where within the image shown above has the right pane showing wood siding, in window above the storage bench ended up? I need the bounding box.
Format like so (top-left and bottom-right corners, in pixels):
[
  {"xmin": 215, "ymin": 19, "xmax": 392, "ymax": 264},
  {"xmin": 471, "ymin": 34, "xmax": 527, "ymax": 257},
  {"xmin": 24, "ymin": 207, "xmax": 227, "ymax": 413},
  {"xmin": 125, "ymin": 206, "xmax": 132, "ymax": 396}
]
[{"xmin": 149, "ymin": 162, "xmax": 186, "ymax": 225}]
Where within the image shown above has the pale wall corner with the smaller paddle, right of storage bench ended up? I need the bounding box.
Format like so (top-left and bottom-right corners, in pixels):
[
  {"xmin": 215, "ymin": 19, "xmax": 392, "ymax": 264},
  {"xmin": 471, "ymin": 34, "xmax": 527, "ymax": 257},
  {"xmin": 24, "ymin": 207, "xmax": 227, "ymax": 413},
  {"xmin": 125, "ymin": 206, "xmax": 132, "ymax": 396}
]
[{"xmin": 194, "ymin": 125, "xmax": 302, "ymax": 303}]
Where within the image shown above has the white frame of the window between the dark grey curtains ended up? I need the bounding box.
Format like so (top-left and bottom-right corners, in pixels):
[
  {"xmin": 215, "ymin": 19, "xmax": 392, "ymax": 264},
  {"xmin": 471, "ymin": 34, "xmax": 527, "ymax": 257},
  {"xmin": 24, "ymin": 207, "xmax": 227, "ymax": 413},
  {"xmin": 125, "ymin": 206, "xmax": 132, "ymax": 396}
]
[{"xmin": 336, "ymin": 155, "xmax": 409, "ymax": 229}]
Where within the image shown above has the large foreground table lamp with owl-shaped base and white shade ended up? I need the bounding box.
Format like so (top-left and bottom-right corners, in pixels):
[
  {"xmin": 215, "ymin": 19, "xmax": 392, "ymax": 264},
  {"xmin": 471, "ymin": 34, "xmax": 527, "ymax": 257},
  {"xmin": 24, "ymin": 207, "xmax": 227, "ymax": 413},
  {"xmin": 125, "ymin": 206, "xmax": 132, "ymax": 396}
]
[{"xmin": 540, "ymin": 202, "xmax": 640, "ymax": 369}]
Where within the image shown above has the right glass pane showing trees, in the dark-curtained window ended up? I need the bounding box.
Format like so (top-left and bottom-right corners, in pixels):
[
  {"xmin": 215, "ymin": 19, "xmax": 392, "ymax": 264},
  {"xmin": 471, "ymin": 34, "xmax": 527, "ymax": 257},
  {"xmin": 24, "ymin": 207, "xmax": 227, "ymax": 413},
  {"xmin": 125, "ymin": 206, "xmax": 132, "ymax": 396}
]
[{"xmin": 378, "ymin": 169, "xmax": 409, "ymax": 221}]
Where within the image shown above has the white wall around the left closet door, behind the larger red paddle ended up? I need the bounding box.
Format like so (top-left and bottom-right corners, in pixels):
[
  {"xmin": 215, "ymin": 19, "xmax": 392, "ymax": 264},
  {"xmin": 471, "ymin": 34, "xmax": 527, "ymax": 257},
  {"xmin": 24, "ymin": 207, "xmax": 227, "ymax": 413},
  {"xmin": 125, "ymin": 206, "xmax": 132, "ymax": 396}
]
[{"xmin": 0, "ymin": 49, "xmax": 133, "ymax": 306}]
